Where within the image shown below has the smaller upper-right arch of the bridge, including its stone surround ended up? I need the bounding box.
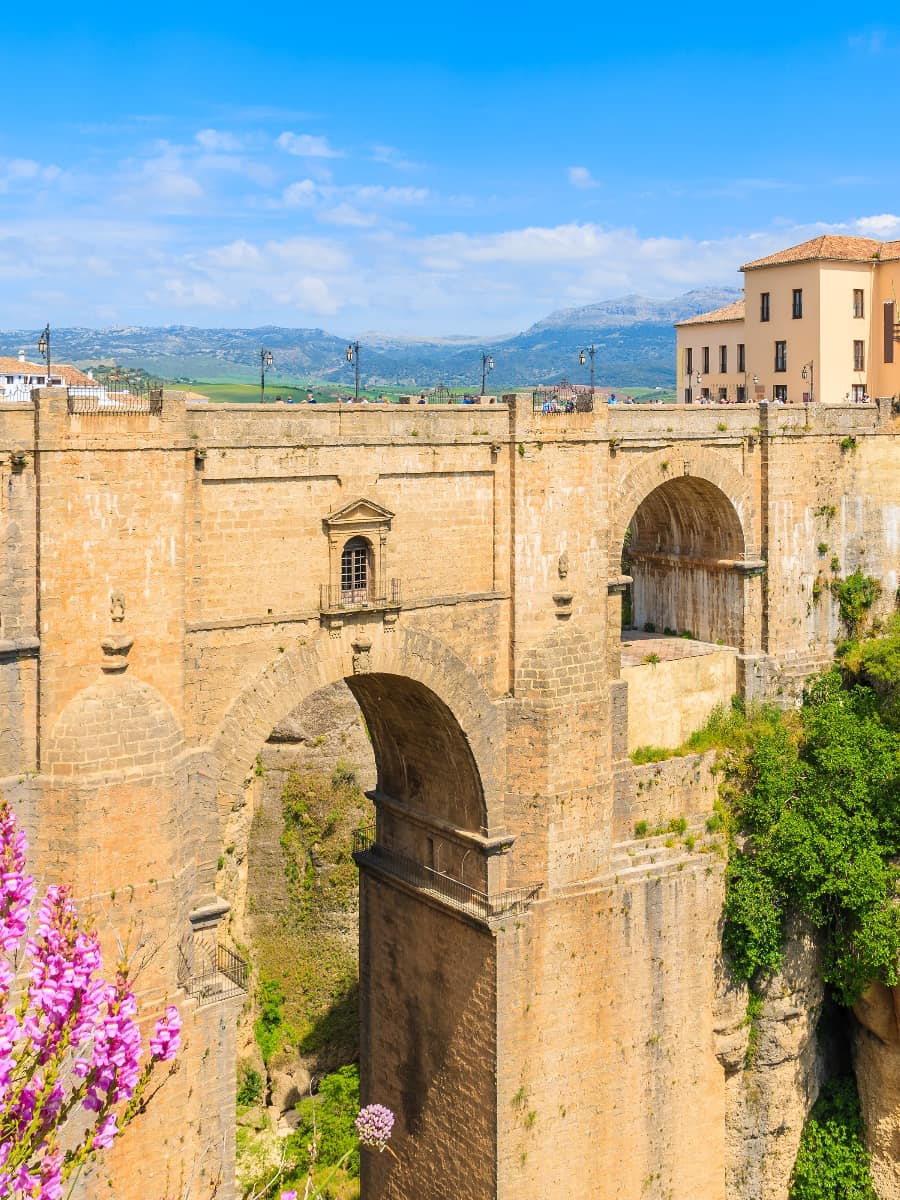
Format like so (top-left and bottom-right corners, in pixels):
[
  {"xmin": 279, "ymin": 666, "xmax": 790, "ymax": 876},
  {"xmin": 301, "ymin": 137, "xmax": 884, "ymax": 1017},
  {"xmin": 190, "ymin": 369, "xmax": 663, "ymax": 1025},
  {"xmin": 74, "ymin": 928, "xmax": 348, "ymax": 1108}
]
[{"xmin": 610, "ymin": 448, "xmax": 761, "ymax": 649}]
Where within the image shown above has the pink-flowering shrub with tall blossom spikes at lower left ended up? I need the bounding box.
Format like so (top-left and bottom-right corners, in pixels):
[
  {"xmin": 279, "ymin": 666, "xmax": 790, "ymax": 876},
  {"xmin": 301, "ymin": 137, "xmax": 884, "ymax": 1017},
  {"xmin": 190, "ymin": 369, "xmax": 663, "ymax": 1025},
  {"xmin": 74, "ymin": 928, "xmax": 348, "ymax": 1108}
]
[{"xmin": 0, "ymin": 799, "xmax": 181, "ymax": 1200}]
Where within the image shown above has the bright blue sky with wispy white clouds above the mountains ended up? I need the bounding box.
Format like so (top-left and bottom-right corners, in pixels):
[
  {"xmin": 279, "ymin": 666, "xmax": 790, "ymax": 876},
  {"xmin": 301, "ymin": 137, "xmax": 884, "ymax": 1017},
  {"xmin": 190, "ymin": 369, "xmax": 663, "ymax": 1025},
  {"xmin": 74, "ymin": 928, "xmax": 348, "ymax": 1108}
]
[{"xmin": 0, "ymin": 0, "xmax": 900, "ymax": 336}]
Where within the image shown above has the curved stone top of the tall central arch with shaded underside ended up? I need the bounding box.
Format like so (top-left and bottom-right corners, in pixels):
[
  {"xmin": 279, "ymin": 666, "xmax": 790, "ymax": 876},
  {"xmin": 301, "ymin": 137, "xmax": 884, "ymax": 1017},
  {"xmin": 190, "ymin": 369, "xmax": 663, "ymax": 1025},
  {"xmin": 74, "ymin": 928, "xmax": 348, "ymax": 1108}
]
[{"xmin": 210, "ymin": 623, "xmax": 504, "ymax": 836}]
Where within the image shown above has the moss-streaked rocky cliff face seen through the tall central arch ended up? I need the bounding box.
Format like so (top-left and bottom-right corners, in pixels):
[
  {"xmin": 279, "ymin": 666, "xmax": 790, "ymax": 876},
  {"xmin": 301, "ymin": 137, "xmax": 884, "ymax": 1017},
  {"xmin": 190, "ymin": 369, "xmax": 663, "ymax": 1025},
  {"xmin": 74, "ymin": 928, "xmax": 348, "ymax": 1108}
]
[{"xmin": 218, "ymin": 683, "xmax": 374, "ymax": 1130}]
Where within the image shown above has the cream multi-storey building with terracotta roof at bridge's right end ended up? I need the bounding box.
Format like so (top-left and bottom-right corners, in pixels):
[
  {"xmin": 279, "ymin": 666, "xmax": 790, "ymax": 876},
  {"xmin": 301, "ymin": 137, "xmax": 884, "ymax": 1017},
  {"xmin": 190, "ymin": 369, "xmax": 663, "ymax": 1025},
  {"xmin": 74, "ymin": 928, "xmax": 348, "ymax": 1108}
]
[{"xmin": 676, "ymin": 234, "xmax": 900, "ymax": 404}]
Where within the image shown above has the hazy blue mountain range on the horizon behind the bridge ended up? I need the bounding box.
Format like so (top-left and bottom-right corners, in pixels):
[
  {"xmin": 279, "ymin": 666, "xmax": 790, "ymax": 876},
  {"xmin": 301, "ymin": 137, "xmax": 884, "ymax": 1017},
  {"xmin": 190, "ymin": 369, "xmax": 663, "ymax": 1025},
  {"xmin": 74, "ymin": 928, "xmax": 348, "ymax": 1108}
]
[{"xmin": 0, "ymin": 288, "xmax": 740, "ymax": 389}]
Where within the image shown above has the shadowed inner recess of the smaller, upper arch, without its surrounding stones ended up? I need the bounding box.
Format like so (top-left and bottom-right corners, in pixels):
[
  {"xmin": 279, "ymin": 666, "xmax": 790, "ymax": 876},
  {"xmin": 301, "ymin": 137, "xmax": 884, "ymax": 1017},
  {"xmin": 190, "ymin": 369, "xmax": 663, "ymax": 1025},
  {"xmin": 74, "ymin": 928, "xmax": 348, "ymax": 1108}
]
[{"xmin": 622, "ymin": 475, "xmax": 746, "ymax": 647}]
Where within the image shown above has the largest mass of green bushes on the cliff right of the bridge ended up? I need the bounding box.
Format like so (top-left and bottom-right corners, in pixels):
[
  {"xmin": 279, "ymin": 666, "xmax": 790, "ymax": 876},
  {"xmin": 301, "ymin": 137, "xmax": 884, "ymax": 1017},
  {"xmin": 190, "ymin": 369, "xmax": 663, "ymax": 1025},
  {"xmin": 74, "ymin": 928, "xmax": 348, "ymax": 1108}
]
[{"xmin": 724, "ymin": 670, "xmax": 900, "ymax": 1004}]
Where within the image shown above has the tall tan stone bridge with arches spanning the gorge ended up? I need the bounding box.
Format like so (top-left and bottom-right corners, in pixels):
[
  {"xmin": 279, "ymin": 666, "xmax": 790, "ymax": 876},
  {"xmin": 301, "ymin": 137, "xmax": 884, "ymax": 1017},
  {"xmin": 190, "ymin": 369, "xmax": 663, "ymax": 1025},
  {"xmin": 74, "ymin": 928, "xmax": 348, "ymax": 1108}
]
[{"xmin": 0, "ymin": 390, "xmax": 900, "ymax": 1200}]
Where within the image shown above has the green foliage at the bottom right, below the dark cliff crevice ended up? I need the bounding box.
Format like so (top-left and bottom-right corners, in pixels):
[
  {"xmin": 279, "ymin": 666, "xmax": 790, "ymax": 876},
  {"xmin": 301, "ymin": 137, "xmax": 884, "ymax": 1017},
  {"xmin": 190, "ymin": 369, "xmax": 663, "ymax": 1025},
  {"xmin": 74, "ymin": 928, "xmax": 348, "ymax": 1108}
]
[{"xmin": 788, "ymin": 1076, "xmax": 877, "ymax": 1200}]
